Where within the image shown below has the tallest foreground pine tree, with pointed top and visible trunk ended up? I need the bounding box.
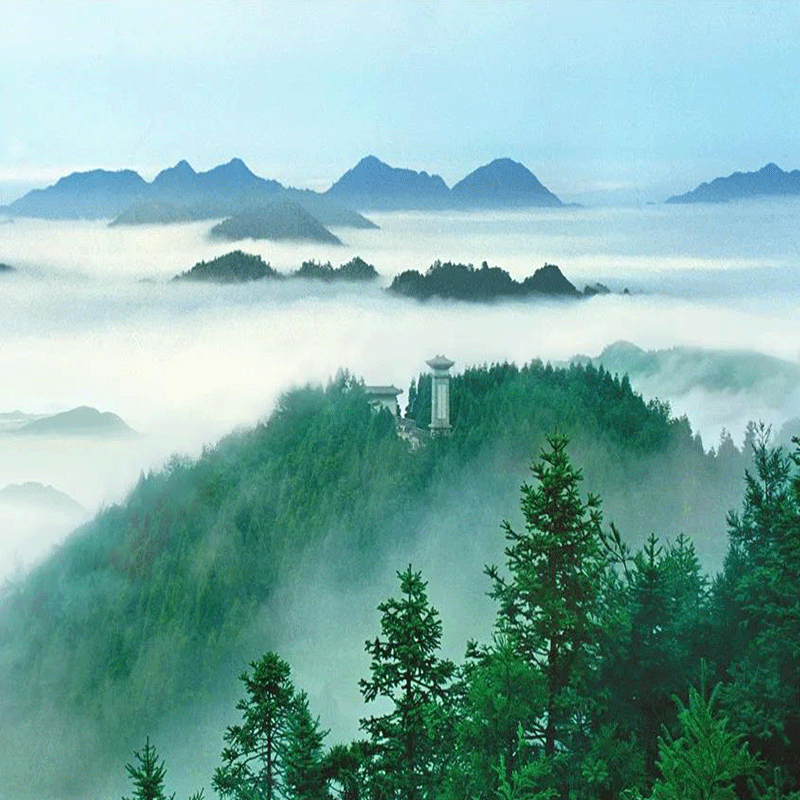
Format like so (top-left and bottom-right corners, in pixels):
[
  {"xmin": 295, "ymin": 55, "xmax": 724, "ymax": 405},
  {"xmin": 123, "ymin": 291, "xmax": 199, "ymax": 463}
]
[{"xmin": 486, "ymin": 434, "xmax": 607, "ymax": 757}]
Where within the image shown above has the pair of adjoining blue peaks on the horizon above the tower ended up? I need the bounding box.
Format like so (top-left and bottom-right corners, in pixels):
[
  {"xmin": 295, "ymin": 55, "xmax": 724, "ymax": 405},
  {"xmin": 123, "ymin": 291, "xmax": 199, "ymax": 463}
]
[{"xmin": 325, "ymin": 156, "xmax": 563, "ymax": 210}]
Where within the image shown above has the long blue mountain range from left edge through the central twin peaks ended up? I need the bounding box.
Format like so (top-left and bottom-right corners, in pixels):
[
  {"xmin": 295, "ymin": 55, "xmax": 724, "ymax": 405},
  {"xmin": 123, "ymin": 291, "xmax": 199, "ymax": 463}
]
[{"xmin": 0, "ymin": 156, "xmax": 562, "ymax": 220}]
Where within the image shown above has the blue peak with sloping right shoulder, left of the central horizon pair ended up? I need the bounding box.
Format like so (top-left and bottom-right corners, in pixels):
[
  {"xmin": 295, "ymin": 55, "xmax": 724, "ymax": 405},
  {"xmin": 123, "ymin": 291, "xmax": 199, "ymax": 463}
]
[{"xmin": 325, "ymin": 156, "xmax": 449, "ymax": 210}]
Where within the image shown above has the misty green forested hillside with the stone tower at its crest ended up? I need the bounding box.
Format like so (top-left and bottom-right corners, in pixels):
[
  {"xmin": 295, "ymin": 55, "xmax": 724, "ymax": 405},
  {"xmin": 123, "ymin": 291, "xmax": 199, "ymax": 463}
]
[{"xmin": 0, "ymin": 362, "xmax": 744, "ymax": 797}]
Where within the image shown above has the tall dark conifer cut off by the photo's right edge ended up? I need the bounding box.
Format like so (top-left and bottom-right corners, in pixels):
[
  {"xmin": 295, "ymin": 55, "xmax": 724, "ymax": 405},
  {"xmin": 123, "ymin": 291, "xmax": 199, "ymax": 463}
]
[{"xmin": 714, "ymin": 427, "xmax": 800, "ymax": 790}]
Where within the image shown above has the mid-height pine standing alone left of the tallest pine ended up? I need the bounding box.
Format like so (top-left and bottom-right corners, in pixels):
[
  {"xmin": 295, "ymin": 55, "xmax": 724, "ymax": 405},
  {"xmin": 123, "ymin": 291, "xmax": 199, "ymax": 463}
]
[{"xmin": 359, "ymin": 565, "xmax": 454, "ymax": 800}]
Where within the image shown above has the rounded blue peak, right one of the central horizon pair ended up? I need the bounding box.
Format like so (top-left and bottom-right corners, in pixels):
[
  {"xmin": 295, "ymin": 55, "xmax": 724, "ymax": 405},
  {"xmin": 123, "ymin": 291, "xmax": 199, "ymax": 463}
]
[{"xmin": 451, "ymin": 158, "xmax": 562, "ymax": 208}]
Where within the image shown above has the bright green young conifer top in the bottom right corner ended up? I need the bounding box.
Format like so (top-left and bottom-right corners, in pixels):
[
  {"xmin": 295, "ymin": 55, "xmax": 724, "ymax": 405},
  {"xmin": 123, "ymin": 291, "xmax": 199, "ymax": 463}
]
[{"xmin": 652, "ymin": 688, "xmax": 758, "ymax": 800}]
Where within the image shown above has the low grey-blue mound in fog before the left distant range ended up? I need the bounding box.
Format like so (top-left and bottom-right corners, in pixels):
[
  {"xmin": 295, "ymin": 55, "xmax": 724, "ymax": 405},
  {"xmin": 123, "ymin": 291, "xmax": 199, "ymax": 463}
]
[{"xmin": 211, "ymin": 200, "xmax": 341, "ymax": 244}]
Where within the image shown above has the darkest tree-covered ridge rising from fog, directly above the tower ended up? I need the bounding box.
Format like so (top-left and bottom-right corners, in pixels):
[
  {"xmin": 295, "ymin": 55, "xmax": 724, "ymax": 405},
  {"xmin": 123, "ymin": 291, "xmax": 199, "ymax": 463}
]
[{"xmin": 389, "ymin": 261, "xmax": 580, "ymax": 301}]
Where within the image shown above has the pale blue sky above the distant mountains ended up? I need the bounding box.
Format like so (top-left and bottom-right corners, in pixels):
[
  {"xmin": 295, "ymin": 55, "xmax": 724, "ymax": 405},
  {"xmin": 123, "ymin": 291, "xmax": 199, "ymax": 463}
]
[{"xmin": 0, "ymin": 0, "xmax": 800, "ymax": 202}]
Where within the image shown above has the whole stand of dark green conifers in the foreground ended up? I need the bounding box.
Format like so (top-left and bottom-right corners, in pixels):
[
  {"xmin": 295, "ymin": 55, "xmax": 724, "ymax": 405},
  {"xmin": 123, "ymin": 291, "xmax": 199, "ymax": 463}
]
[{"xmin": 111, "ymin": 428, "xmax": 800, "ymax": 800}]
